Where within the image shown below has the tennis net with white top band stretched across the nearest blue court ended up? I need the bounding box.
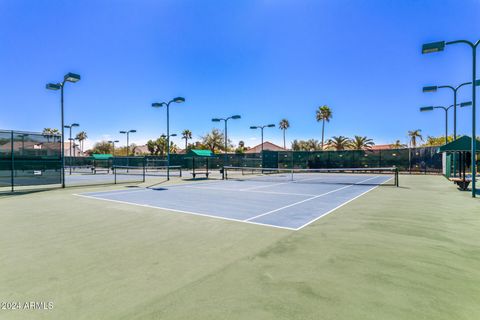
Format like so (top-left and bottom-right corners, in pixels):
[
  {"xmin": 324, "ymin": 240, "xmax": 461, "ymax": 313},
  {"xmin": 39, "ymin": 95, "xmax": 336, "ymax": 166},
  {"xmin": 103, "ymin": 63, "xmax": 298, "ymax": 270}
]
[{"xmin": 223, "ymin": 166, "xmax": 398, "ymax": 187}]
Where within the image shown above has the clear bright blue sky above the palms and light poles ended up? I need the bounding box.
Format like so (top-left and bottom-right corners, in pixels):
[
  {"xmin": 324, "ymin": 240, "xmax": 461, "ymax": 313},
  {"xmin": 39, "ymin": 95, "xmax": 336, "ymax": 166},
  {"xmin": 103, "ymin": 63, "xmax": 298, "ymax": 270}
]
[{"xmin": 0, "ymin": 0, "xmax": 480, "ymax": 146}]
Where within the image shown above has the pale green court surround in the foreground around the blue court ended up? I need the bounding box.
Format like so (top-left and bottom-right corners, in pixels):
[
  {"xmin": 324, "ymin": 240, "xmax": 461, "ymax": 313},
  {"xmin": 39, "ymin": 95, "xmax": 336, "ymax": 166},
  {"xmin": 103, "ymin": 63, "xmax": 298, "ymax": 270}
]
[{"xmin": 0, "ymin": 175, "xmax": 480, "ymax": 320}]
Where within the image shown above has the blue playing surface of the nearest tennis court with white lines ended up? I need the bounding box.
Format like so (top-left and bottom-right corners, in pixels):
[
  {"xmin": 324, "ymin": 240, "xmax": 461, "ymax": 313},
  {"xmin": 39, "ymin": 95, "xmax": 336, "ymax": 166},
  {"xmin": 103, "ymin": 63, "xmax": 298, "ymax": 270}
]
[{"xmin": 79, "ymin": 174, "xmax": 392, "ymax": 230}]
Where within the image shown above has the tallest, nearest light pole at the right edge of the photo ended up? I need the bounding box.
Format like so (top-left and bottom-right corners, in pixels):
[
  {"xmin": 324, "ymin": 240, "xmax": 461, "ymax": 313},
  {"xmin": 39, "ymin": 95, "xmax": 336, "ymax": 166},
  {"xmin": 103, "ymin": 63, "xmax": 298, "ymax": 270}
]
[{"xmin": 422, "ymin": 40, "xmax": 480, "ymax": 198}]
